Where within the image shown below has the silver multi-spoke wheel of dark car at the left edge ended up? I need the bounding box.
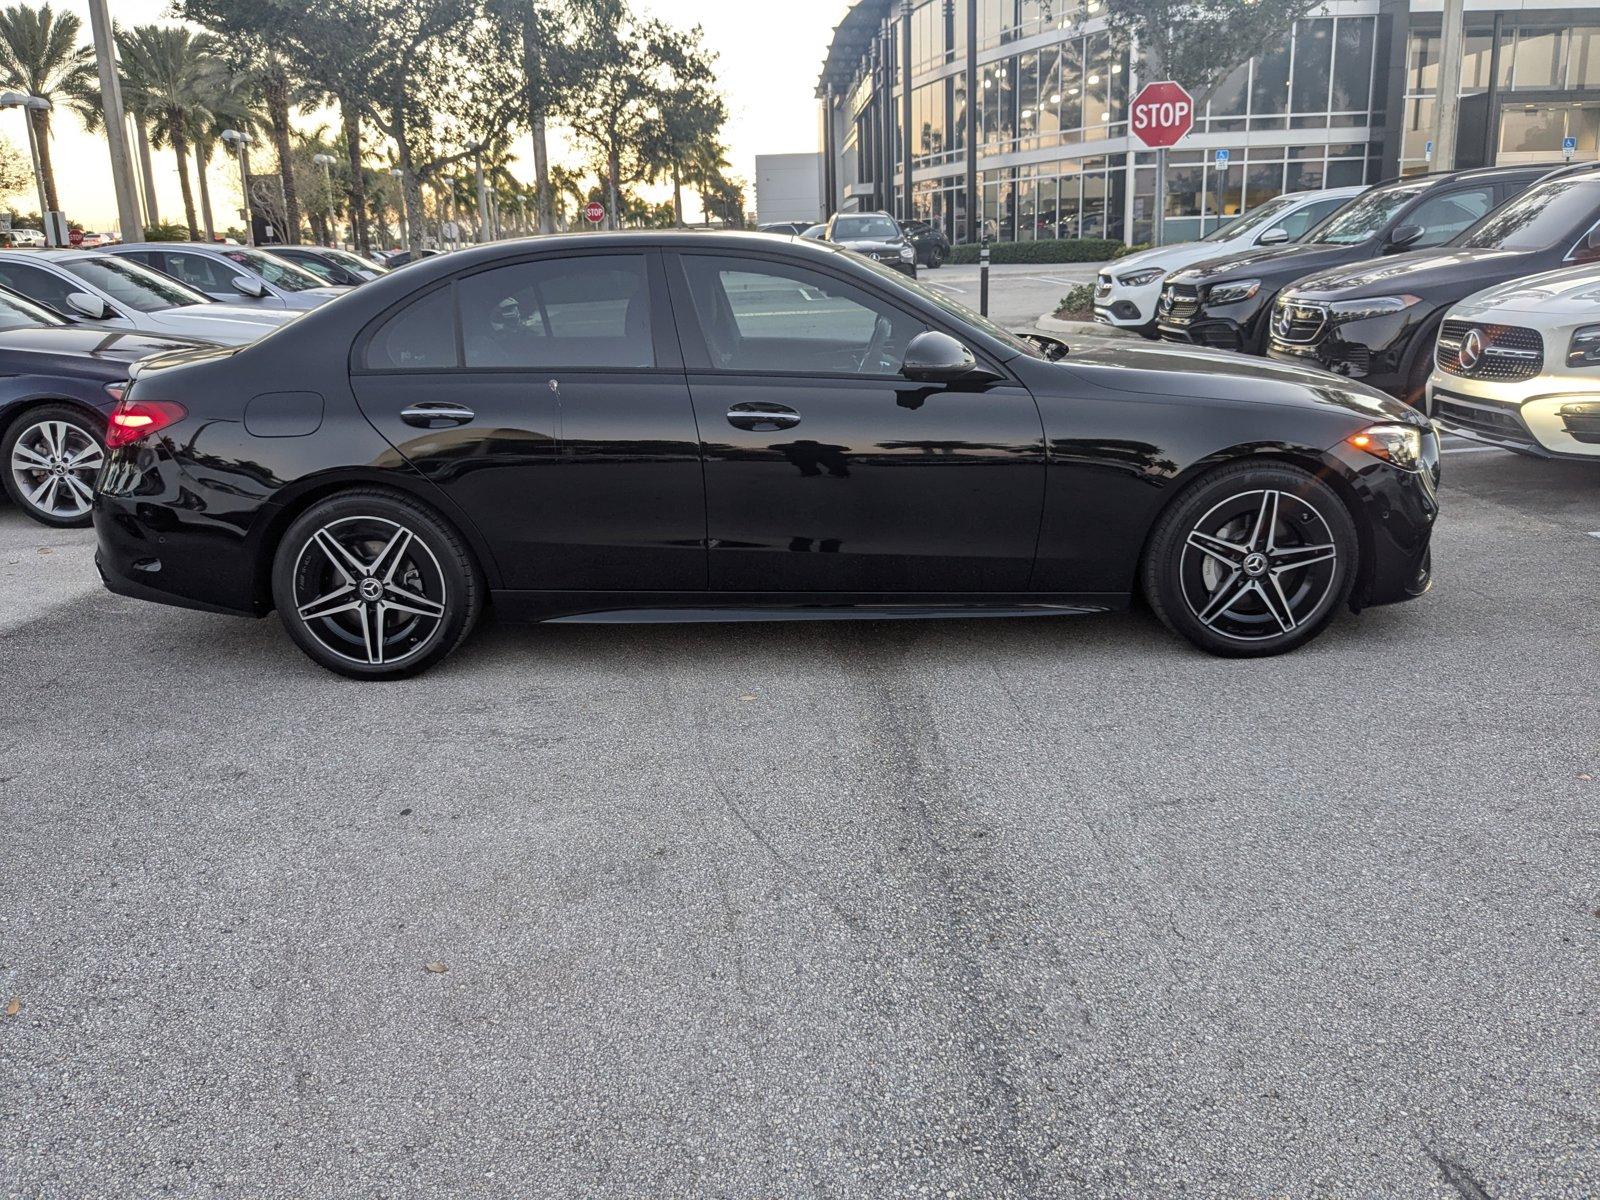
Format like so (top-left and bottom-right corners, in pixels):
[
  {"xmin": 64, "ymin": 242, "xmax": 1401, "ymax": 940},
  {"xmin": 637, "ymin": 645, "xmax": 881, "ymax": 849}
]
[{"xmin": 0, "ymin": 403, "xmax": 106, "ymax": 530}]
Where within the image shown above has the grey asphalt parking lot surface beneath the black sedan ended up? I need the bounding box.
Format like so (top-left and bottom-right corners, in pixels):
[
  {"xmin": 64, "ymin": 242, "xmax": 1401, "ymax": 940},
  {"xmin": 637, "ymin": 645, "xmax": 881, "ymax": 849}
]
[{"xmin": 0, "ymin": 428, "xmax": 1600, "ymax": 1200}]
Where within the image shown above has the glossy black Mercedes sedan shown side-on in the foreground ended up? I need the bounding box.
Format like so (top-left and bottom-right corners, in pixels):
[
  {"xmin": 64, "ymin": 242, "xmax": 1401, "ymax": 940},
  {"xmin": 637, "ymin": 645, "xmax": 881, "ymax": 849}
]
[{"xmin": 94, "ymin": 232, "xmax": 1438, "ymax": 678}]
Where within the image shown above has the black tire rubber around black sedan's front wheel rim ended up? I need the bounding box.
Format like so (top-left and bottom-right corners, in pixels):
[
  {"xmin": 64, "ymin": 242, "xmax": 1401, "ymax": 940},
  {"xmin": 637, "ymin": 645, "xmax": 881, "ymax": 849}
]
[{"xmin": 1141, "ymin": 462, "xmax": 1360, "ymax": 658}]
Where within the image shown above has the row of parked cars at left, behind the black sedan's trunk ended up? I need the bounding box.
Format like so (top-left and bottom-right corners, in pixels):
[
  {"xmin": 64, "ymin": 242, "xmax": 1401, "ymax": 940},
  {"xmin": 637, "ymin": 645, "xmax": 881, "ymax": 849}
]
[{"xmin": 0, "ymin": 242, "xmax": 387, "ymax": 526}]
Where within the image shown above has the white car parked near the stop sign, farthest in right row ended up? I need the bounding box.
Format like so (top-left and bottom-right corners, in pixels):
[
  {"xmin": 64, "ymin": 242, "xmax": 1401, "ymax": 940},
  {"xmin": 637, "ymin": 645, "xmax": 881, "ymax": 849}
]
[{"xmin": 1094, "ymin": 187, "xmax": 1366, "ymax": 338}]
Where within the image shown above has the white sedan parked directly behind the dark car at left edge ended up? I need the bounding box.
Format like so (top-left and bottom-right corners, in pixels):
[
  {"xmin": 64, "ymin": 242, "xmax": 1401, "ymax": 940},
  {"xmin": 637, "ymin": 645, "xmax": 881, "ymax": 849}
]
[{"xmin": 0, "ymin": 250, "xmax": 298, "ymax": 346}]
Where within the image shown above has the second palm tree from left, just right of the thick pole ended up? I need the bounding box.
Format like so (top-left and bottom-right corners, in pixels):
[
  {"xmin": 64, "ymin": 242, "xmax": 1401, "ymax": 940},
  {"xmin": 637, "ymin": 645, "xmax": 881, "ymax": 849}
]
[{"xmin": 117, "ymin": 26, "xmax": 226, "ymax": 240}]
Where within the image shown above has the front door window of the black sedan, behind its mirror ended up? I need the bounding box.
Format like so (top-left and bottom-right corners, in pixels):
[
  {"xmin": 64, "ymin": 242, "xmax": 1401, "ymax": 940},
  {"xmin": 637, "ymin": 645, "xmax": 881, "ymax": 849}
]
[{"xmin": 683, "ymin": 254, "xmax": 926, "ymax": 374}]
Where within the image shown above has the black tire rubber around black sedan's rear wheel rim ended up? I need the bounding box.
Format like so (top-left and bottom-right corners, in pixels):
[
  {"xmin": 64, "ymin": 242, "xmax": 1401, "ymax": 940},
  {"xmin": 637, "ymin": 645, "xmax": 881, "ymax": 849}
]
[{"xmin": 272, "ymin": 490, "xmax": 483, "ymax": 680}]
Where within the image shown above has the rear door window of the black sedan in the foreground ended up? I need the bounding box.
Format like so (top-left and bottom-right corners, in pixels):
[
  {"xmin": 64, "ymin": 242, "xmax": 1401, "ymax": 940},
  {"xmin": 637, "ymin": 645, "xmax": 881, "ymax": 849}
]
[{"xmin": 456, "ymin": 254, "xmax": 656, "ymax": 370}]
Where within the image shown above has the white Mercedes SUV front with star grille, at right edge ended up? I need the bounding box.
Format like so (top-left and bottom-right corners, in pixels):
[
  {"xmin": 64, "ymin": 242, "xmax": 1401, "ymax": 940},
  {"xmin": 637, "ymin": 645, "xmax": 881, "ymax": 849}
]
[{"xmin": 1427, "ymin": 264, "xmax": 1600, "ymax": 461}]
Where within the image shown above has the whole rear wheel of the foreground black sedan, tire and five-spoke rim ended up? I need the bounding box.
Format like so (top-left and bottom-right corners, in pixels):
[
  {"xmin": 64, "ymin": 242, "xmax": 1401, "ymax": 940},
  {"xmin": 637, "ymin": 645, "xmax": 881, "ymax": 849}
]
[{"xmin": 272, "ymin": 488, "xmax": 485, "ymax": 680}]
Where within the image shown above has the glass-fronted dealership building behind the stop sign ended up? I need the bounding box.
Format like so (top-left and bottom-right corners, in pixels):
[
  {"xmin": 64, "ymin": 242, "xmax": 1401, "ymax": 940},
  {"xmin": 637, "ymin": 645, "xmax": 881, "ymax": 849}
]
[{"xmin": 818, "ymin": 0, "xmax": 1600, "ymax": 243}]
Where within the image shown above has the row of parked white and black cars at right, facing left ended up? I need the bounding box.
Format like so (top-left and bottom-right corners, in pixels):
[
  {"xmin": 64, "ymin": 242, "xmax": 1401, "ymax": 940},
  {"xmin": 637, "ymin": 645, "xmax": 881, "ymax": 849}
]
[{"xmin": 1094, "ymin": 163, "xmax": 1600, "ymax": 470}]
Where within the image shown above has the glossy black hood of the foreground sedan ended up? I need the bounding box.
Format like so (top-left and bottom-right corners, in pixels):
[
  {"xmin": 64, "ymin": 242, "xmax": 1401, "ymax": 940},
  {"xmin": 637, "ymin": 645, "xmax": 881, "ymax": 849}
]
[{"xmin": 1059, "ymin": 338, "xmax": 1427, "ymax": 426}]
